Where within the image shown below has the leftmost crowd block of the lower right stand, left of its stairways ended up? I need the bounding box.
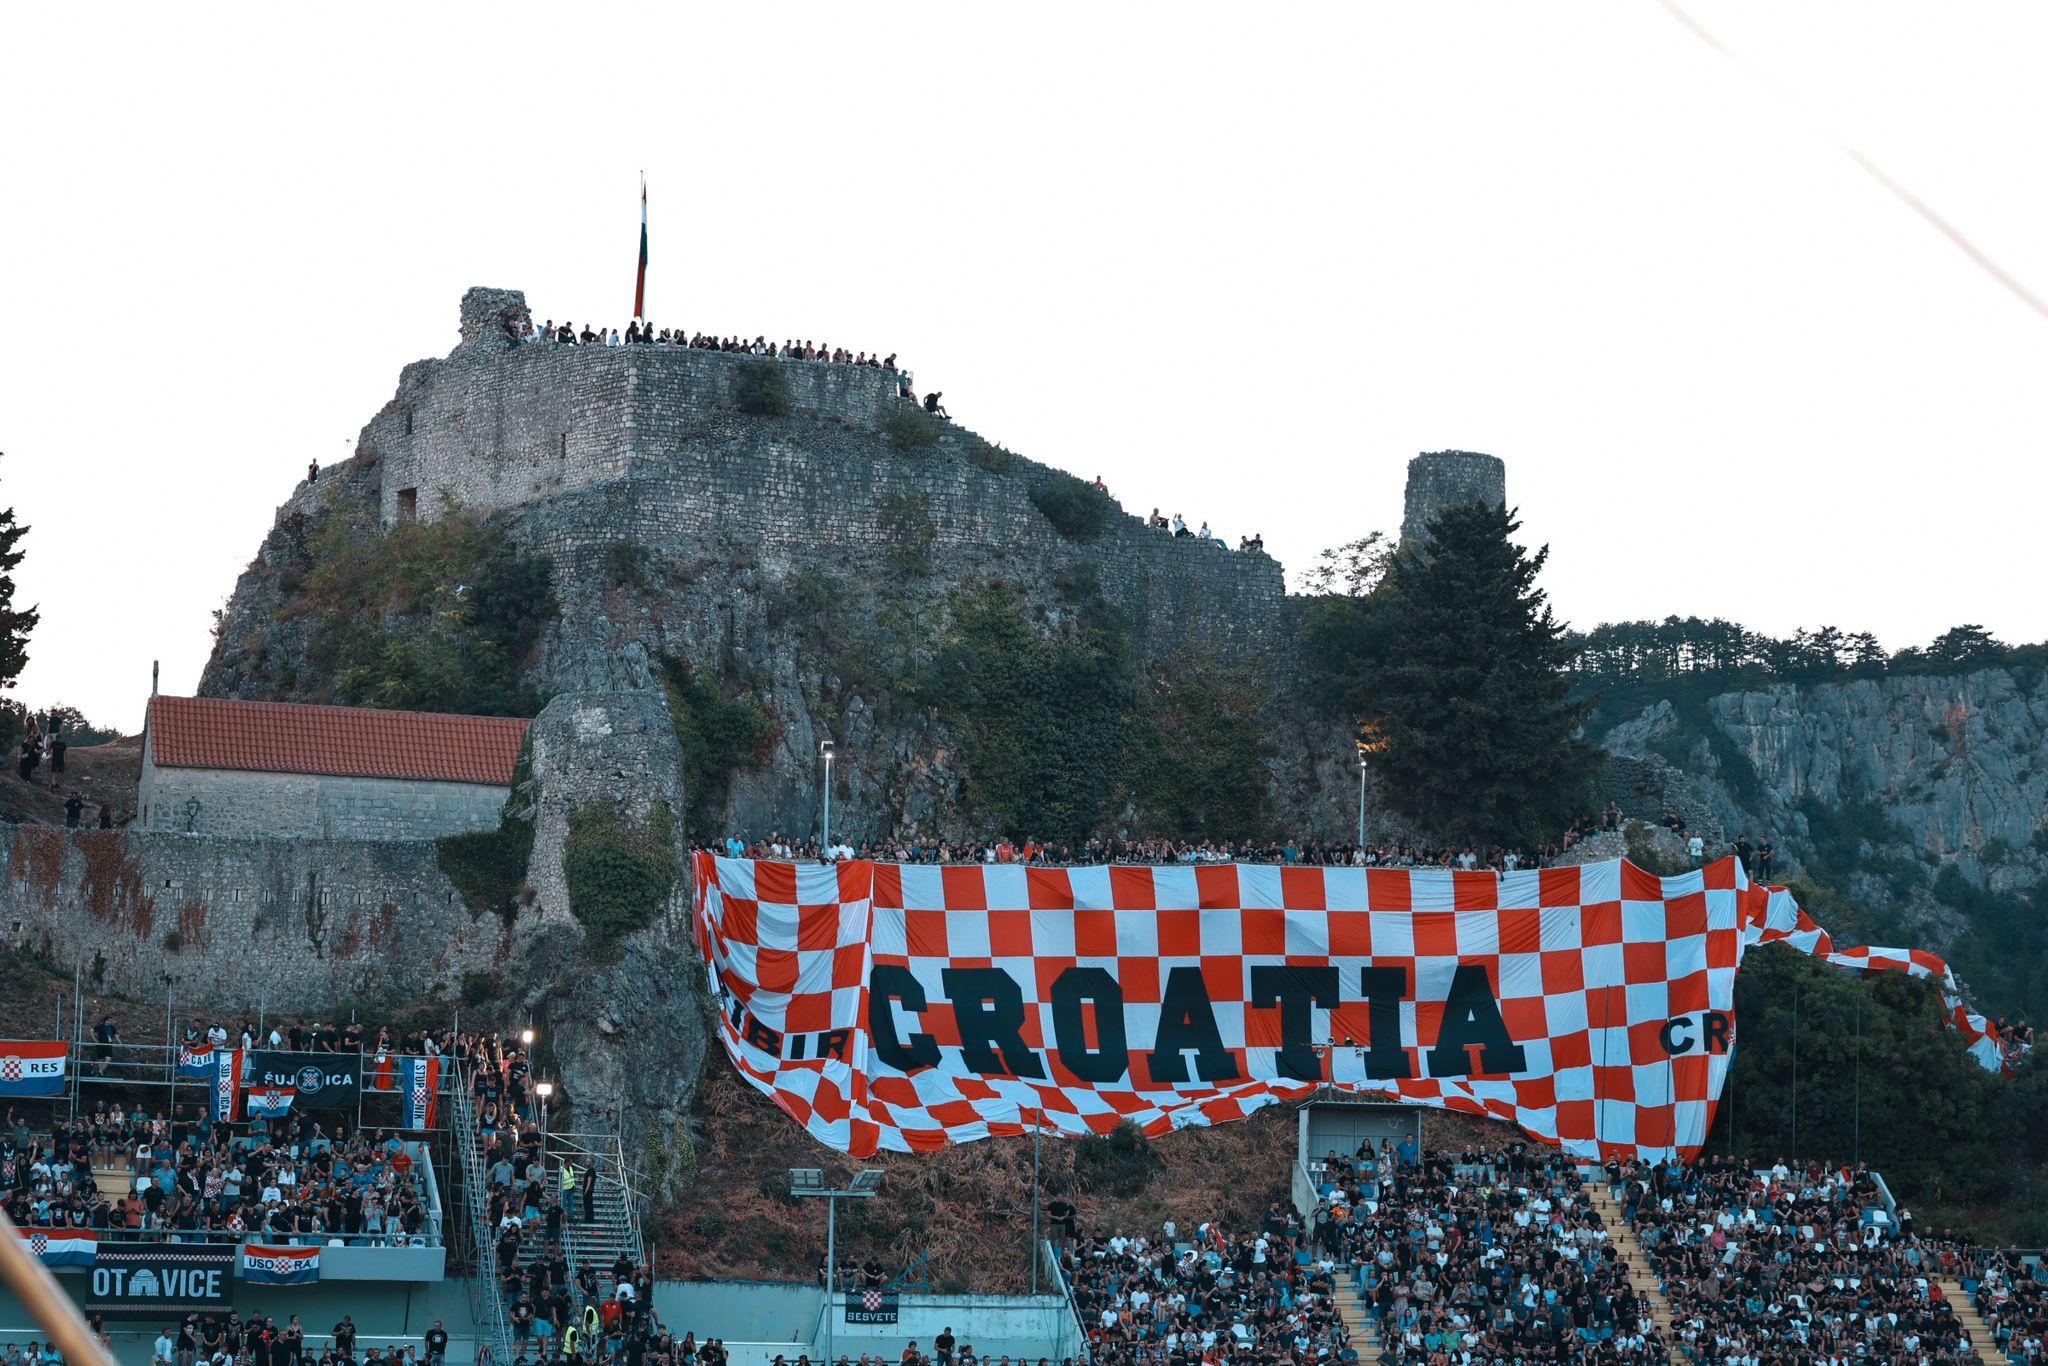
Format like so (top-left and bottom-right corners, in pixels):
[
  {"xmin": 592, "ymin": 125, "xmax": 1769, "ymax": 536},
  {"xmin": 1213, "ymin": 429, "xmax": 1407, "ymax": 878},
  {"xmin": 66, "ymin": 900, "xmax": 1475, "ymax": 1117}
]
[{"xmin": 1061, "ymin": 1216, "xmax": 1358, "ymax": 1366}]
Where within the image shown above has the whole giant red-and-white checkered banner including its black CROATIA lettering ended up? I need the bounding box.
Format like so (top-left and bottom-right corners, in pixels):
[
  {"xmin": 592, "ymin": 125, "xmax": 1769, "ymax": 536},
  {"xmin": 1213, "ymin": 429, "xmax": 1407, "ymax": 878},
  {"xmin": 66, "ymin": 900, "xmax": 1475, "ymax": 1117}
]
[{"xmin": 692, "ymin": 854, "xmax": 2001, "ymax": 1159}]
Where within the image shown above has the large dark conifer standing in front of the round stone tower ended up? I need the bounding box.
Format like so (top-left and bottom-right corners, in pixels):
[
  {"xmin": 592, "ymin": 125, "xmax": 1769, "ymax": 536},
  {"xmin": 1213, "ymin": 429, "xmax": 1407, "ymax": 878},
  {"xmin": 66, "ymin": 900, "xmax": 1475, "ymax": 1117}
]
[{"xmin": 1360, "ymin": 504, "xmax": 1602, "ymax": 846}]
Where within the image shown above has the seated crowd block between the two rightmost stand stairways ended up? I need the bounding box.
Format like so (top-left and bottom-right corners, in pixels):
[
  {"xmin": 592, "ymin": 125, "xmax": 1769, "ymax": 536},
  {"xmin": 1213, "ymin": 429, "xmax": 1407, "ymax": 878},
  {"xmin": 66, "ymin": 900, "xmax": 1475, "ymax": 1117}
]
[{"xmin": 1608, "ymin": 1157, "xmax": 1985, "ymax": 1364}]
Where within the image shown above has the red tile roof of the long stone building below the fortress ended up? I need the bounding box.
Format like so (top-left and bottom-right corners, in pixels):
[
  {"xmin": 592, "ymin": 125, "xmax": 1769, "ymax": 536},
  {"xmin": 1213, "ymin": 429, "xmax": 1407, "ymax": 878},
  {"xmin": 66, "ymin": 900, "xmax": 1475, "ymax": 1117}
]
[{"xmin": 150, "ymin": 696, "xmax": 532, "ymax": 786}]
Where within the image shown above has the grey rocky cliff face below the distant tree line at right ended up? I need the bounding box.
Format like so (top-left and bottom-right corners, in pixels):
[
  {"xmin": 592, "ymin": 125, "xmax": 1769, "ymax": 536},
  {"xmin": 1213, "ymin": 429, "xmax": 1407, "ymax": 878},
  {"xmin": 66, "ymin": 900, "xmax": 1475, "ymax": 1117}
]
[{"xmin": 1602, "ymin": 668, "xmax": 2048, "ymax": 1012}]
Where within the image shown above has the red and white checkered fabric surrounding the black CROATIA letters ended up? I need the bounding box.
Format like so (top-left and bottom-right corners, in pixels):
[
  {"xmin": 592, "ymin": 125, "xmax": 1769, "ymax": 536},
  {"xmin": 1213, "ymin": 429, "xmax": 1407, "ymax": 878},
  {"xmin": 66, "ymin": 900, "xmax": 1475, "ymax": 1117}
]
[{"xmin": 694, "ymin": 854, "xmax": 1995, "ymax": 1159}]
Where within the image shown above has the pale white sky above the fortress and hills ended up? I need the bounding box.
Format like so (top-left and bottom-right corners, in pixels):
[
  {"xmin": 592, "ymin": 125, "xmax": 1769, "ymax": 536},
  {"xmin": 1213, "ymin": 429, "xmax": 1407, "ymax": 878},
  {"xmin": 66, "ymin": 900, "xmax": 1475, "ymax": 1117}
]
[{"xmin": 0, "ymin": 0, "xmax": 2048, "ymax": 731}]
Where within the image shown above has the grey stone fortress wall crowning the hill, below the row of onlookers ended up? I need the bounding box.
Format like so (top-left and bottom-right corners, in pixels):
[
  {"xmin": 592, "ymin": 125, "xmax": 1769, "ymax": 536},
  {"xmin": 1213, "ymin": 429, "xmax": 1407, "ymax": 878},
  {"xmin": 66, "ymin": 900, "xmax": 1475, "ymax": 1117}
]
[{"xmin": 360, "ymin": 289, "xmax": 1286, "ymax": 655}]
